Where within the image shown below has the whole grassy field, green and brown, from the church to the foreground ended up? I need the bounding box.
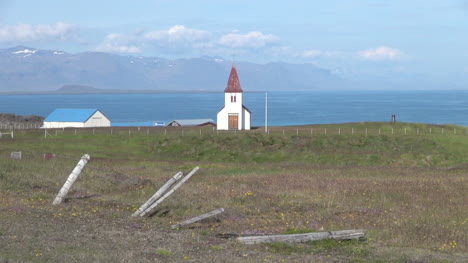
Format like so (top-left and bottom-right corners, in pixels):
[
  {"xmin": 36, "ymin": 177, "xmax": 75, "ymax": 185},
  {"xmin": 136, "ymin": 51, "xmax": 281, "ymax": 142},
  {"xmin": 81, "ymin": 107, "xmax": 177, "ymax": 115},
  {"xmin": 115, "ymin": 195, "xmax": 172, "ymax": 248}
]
[{"xmin": 0, "ymin": 123, "xmax": 468, "ymax": 262}]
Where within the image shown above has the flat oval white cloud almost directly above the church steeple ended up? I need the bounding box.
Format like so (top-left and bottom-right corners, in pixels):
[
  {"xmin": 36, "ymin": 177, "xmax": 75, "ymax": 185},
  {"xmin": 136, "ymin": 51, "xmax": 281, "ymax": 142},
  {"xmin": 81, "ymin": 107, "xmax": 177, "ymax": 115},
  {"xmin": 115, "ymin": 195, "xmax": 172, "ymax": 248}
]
[{"xmin": 218, "ymin": 31, "xmax": 279, "ymax": 48}]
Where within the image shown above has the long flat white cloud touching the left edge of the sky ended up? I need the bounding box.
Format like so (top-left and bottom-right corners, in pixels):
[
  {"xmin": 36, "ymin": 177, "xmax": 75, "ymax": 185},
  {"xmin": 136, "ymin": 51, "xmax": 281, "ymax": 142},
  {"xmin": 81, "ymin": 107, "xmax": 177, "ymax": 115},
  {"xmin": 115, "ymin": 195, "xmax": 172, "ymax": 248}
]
[{"xmin": 0, "ymin": 22, "xmax": 77, "ymax": 43}]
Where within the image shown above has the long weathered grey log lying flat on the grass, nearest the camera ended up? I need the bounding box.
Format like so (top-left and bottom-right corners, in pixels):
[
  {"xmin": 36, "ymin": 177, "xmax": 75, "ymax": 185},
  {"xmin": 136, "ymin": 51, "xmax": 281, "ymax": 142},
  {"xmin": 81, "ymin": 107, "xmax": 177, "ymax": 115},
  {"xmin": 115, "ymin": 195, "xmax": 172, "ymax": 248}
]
[{"xmin": 237, "ymin": 229, "xmax": 365, "ymax": 245}]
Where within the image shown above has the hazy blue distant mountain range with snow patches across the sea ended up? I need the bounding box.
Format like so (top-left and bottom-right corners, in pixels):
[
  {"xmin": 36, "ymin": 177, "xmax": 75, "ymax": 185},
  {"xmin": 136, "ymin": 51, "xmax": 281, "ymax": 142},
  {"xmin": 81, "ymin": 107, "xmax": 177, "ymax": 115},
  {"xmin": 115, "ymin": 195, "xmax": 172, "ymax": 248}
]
[{"xmin": 0, "ymin": 46, "xmax": 344, "ymax": 93}]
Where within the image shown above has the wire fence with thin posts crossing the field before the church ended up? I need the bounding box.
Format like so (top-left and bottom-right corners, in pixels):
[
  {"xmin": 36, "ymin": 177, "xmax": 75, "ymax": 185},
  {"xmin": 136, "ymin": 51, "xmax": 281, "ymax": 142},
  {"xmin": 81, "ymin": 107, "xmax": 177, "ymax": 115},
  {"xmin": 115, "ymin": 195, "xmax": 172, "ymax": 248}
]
[{"xmin": 0, "ymin": 125, "xmax": 468, "ymax": 139}]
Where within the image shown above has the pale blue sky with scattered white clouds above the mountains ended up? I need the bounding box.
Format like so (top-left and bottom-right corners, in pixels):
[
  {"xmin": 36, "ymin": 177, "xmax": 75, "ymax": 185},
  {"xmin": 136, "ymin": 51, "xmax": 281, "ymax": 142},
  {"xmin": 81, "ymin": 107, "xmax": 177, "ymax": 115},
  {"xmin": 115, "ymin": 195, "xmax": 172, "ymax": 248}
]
[{"xmin": 0, "ymin": 0, "xmax": 468, "ymax": 89}]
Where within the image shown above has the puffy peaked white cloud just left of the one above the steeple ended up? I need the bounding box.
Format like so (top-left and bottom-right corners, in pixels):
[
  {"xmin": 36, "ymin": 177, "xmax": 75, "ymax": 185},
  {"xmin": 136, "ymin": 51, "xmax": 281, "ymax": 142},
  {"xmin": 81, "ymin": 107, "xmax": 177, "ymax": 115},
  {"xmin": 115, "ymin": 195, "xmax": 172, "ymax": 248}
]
[{"xmin": 144, "ymin": 25, "xmax": 211, "ymax": 46}]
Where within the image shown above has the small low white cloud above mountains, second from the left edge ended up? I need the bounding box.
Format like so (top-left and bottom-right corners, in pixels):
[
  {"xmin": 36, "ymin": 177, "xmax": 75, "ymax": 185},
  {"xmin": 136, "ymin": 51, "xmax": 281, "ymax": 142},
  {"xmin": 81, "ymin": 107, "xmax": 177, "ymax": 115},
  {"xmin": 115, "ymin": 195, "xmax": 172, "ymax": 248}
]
[{"xmin": 96, "ymin": 33, "xmax": 141, "ymax": 53}]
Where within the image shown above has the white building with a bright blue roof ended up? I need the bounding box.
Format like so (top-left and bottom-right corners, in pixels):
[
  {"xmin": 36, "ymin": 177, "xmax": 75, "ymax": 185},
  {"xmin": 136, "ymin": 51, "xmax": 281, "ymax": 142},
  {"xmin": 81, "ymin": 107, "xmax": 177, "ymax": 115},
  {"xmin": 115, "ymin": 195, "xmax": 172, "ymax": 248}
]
[{"xmin": 42, "ymin": 109, "xmax": 110, "ymax": 128}]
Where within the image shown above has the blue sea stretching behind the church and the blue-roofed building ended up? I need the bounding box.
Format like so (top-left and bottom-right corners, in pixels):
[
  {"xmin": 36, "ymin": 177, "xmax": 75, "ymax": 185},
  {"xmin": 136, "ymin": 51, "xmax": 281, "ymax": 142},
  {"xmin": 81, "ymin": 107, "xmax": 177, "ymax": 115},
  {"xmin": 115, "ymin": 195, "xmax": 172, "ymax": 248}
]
[{"xmin": 0, "ymin": 91, "xmax": 468, "ymax": 126}]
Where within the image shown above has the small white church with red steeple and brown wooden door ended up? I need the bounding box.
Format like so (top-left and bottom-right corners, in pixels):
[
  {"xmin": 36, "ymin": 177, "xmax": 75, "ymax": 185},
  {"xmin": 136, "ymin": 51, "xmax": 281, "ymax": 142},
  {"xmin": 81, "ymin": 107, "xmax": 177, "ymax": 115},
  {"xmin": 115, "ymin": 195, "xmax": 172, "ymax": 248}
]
[{"xmin": 216, "ymin": 64, "xmax": 251, "ymax": 130}]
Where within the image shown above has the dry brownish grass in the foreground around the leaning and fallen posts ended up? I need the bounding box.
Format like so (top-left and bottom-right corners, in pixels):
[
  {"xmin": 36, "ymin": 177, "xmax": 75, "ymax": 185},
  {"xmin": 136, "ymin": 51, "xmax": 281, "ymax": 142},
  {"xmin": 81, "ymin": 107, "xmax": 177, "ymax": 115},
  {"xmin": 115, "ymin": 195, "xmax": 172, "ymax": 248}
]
[{"xmin": 0, "ymin": 127, "xmax": 468, "ymax": 262}]
